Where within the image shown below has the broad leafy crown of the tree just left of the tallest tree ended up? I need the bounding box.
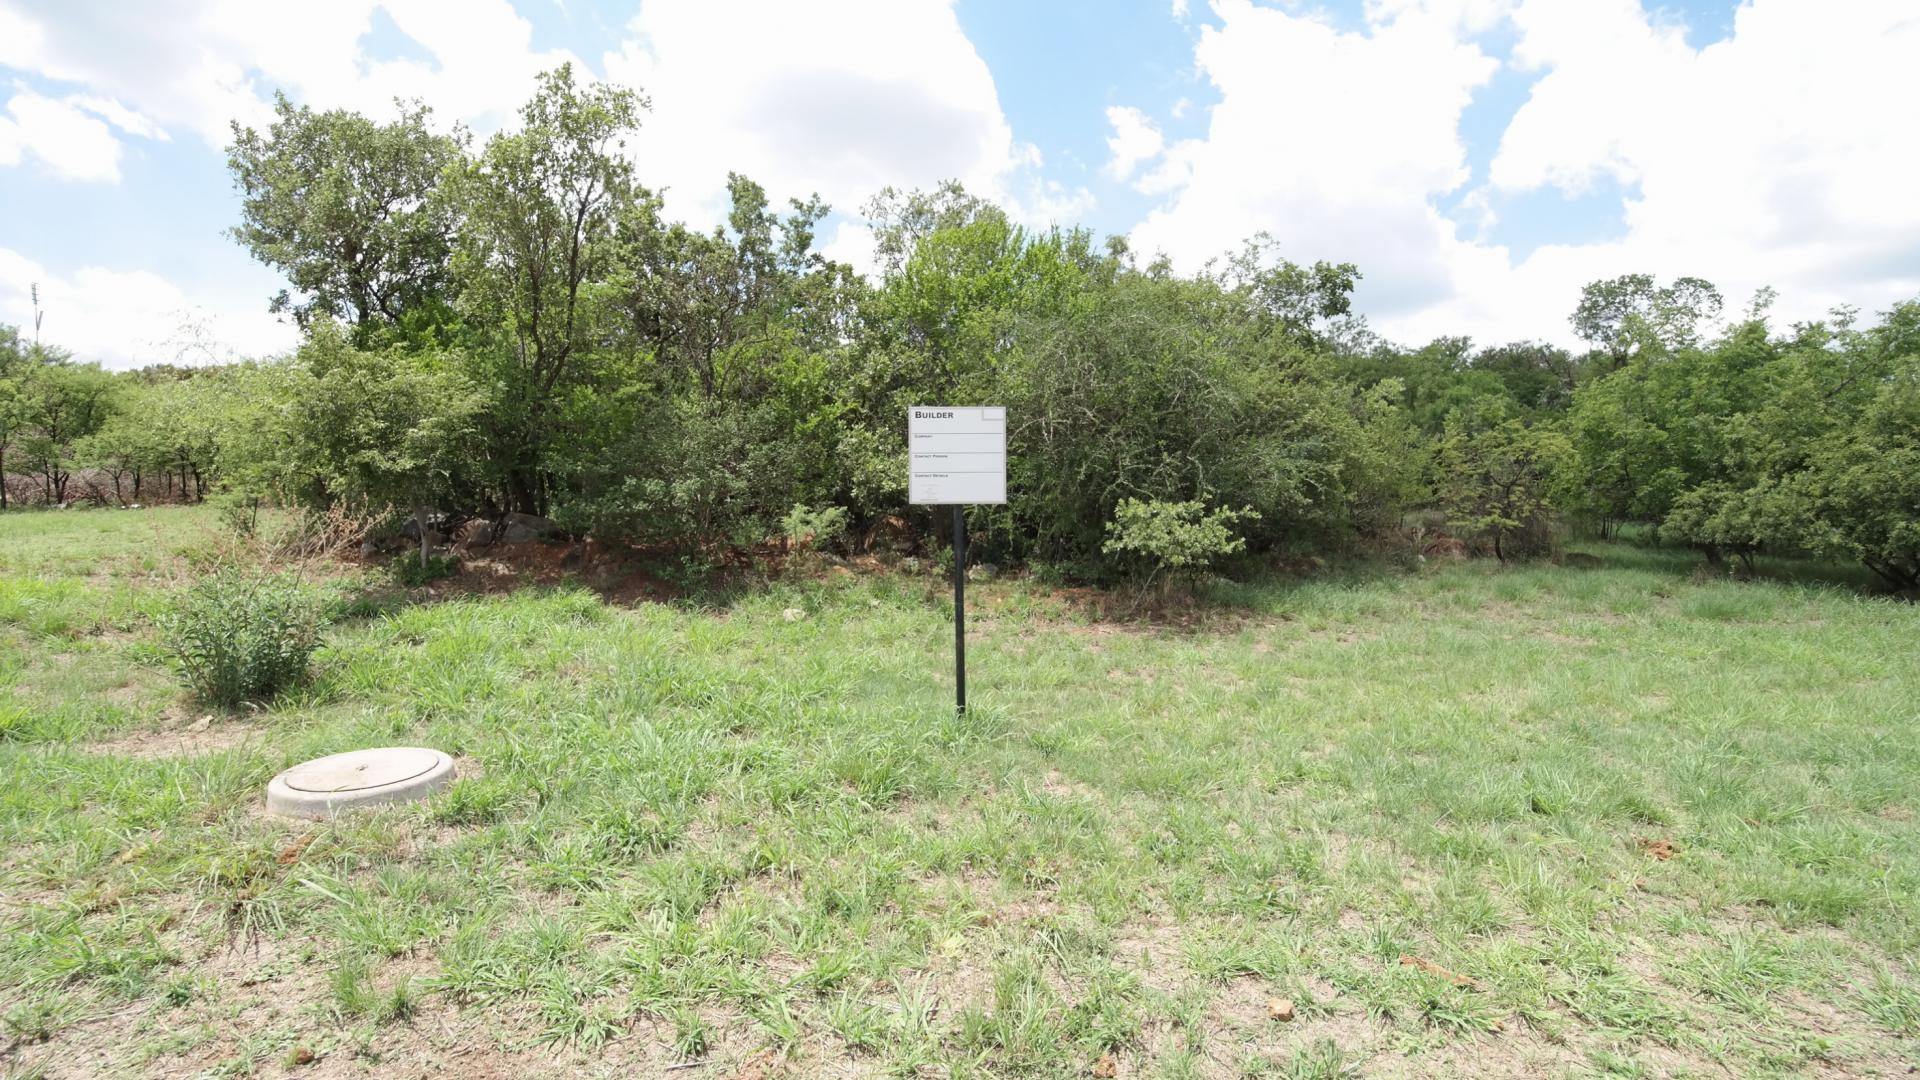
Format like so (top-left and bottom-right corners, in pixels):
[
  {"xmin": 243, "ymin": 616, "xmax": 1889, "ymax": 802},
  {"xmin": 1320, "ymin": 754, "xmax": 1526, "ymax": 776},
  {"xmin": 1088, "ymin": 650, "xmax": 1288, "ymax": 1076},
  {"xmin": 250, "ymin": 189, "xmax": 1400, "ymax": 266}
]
[{"xmin": 227, "ymin": 94, "xmax": 465, "ymax": 327}]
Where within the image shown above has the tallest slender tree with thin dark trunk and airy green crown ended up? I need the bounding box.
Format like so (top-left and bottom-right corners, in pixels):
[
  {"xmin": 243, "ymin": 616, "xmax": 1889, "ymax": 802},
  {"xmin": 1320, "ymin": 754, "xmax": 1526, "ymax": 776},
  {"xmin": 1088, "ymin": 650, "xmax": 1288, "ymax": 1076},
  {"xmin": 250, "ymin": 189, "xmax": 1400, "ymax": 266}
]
[{"xmin": 453, "ymin": 65, "xmax": 647, "ymax": 513}]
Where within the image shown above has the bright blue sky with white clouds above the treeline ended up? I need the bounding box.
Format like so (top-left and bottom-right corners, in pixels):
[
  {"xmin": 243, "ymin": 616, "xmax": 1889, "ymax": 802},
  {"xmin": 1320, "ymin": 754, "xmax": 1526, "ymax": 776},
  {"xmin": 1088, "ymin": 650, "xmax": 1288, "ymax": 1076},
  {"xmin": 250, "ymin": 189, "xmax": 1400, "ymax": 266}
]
[{"xmin": 0, "ymin": 0, "xmax": 1920, "ymax": 367}]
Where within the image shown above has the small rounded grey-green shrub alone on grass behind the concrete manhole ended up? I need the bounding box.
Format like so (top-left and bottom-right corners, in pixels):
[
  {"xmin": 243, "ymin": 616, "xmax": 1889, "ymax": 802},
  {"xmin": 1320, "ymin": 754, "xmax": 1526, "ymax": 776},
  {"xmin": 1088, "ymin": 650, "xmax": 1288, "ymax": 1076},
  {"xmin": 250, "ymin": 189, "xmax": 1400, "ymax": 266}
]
[{"xmin": 159, "ymin": 569, "xmax": 321, "ymax": 707}]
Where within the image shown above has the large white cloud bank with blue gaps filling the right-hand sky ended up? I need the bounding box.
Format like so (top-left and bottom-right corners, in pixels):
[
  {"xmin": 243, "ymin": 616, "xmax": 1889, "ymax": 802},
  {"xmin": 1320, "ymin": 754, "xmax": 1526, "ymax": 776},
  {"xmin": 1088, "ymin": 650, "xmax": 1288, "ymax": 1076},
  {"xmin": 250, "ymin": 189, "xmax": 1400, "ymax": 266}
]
[{"xmin": 1116, "ymin": 0, "xmax": 1920, "ymax": 344}]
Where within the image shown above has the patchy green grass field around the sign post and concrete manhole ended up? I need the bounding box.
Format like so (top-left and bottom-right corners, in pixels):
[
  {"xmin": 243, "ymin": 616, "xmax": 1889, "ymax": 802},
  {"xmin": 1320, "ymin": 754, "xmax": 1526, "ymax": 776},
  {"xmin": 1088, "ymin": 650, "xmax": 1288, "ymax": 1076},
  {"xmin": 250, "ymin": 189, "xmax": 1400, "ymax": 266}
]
[{"xmin": 0, "ymin": 509, "xmax": 1920, "ymax": 1080}]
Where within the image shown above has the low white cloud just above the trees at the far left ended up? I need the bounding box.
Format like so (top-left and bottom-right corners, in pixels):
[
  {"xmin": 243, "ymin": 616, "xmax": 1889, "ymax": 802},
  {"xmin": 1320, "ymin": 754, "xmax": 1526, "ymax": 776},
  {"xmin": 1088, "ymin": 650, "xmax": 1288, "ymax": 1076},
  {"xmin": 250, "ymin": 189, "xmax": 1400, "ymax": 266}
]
[{"xmin": 0, "ymin": 248, "xmax": 298, "ymax": 369}]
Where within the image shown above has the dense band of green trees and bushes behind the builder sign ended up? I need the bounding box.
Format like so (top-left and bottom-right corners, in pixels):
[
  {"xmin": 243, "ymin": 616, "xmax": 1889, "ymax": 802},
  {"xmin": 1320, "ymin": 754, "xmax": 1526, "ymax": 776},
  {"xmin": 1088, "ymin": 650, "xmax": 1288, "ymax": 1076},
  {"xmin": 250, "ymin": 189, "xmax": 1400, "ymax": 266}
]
[{"xmin": 0, "ymin": 67, "xmax": 1920, "ymax": 588}]
